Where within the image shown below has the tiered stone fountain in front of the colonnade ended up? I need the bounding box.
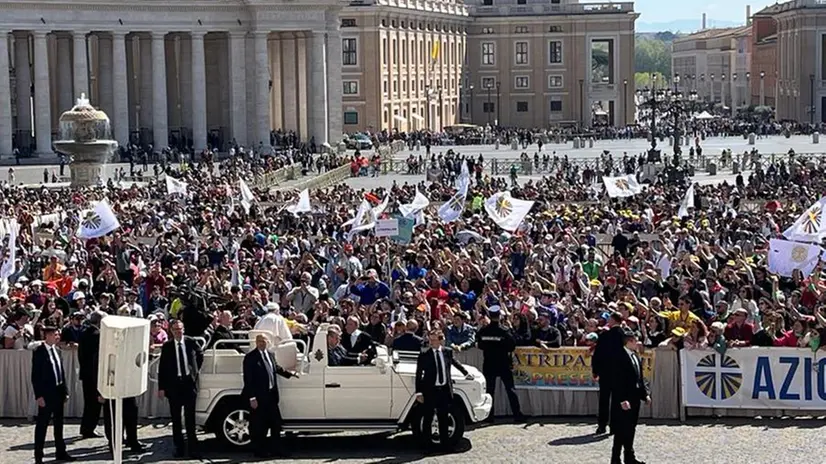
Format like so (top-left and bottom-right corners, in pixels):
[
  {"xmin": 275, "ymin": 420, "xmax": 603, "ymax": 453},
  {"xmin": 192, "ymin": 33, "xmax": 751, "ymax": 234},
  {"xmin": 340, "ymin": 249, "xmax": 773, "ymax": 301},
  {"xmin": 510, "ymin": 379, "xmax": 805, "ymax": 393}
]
[{"xmin": 54, "ymin": 94, "xmax": 118, "ymax": 187}]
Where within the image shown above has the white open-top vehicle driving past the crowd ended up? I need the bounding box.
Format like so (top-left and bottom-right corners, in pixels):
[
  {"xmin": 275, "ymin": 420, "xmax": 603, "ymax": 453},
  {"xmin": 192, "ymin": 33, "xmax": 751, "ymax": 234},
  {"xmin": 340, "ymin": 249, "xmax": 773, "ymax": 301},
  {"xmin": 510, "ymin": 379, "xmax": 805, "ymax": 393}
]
[{"xmin": 188, "ymin": 324, "xmax": 492, "ymax": 447}]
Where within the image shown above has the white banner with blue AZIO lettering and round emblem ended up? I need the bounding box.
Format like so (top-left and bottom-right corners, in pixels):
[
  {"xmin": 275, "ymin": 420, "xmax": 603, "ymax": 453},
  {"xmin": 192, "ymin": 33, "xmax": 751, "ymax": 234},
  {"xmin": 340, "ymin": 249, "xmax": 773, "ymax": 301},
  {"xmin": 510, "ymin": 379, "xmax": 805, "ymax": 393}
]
[{"xmin": 680, "ymin": 348, "xmax": 826, "ymax": 410}]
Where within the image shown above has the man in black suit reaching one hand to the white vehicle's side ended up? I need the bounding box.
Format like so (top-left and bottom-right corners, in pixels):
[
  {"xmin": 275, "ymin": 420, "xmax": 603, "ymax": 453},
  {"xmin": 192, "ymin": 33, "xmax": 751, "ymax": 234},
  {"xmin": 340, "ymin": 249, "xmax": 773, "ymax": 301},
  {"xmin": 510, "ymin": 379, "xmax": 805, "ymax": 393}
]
[{"xmin": 241, "ymin": 334, "xmax": 298, "ymax": 458}]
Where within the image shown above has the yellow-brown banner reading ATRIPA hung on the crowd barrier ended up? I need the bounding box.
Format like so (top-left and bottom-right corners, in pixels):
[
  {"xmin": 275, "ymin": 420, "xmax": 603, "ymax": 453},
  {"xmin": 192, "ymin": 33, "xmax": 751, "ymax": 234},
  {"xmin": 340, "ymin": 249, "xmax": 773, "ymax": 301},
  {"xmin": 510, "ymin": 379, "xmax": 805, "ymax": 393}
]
[{"xmin": 513, "ymin": 347, "xmax": 654, "ymax": 390}]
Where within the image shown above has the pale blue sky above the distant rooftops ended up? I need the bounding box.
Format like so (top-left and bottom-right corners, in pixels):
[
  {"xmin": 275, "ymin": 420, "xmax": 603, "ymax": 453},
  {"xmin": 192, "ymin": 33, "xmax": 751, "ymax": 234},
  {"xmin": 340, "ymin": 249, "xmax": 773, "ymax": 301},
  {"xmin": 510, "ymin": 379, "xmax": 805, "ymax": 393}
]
[{"xmin": 628, "ymin": 0, "xmax": 786, "ymax": 23}]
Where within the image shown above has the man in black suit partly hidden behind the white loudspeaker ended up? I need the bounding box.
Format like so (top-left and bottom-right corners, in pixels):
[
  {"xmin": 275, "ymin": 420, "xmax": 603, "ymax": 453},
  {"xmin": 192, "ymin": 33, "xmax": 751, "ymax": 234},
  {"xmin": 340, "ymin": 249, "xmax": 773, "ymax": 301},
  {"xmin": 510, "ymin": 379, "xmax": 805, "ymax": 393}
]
[{"xmin": 77, "ymin": 311, "xmax": 106, "ymax": 438}]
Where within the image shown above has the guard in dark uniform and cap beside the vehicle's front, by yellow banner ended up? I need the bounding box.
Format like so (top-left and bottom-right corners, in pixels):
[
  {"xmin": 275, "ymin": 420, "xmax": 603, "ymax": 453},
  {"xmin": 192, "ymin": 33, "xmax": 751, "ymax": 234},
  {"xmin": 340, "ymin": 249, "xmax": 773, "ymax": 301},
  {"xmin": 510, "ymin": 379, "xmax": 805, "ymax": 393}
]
[{"xmin": 476, "ymin": 305, "xmax": 525, "ymax": 422}]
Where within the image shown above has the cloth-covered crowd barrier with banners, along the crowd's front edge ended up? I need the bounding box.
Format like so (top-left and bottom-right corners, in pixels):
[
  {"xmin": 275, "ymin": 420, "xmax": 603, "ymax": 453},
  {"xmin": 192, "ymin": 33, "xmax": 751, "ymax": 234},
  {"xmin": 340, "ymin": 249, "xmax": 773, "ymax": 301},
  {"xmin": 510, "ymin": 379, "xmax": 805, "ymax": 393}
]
[{"xmin": 0, "ymin": 348, "xmax": 812, "ymax": 419}]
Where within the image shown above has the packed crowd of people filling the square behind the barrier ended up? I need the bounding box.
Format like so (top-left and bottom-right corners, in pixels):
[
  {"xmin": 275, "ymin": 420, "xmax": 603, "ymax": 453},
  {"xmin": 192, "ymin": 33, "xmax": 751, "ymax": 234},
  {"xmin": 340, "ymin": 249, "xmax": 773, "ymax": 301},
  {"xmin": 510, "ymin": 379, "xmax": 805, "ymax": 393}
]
[{"xmin": 0, "ymin": 140, "xmax": 826, "ymax": 360}]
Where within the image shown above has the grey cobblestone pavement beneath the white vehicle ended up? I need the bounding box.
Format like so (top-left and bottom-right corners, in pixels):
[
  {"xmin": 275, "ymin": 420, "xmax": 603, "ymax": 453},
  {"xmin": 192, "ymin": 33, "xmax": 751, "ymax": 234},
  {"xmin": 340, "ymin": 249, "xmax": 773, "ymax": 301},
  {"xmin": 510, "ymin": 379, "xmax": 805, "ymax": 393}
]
[{"xmin": 0, "ymin": 418, "xmax": 824, "ymax": 464}]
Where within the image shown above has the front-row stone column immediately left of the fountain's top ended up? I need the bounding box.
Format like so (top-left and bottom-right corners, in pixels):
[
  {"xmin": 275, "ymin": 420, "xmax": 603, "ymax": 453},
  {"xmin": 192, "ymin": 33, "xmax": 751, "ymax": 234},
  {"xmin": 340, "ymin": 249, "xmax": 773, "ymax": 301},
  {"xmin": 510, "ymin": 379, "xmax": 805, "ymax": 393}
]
[{"xmin": 34, "ymin": 31, "xmax": 52, "ymax": 156}]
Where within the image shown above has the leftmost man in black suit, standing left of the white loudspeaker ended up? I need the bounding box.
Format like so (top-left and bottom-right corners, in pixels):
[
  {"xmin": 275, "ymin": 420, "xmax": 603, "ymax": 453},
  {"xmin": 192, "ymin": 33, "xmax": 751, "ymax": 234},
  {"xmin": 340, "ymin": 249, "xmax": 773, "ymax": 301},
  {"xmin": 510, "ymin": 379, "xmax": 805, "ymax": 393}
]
[{"xmin": 32, "ymin": 327, "xmax": 75, "ymax": 464}]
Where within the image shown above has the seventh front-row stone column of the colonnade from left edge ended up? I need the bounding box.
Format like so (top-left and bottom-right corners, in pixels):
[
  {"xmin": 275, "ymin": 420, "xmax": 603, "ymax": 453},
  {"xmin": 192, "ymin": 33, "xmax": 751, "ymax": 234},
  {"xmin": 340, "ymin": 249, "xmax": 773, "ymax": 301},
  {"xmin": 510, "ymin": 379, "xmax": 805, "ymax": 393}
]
[{"xmin": 229, "ymin": 32, "xmax": 246, "ymax": 146}]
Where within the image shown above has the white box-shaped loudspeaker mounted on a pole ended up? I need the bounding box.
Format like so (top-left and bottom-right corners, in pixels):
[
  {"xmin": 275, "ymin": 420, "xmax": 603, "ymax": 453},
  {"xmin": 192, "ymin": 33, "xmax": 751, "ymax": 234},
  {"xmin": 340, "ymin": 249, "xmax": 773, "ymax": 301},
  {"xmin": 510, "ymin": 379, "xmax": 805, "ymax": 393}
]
[{"xmin": 98, "ymin": 316, "xmax": 149, "ymax": 399}]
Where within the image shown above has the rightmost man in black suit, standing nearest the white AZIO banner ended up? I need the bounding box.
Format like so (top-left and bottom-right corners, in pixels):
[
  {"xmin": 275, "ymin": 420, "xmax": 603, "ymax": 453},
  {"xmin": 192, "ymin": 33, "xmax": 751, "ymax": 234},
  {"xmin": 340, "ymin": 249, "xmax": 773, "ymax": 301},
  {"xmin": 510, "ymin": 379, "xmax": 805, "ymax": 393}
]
[{"xmin": 611, "ymin": 328, "xmax": 651, "ymax": 464}]
